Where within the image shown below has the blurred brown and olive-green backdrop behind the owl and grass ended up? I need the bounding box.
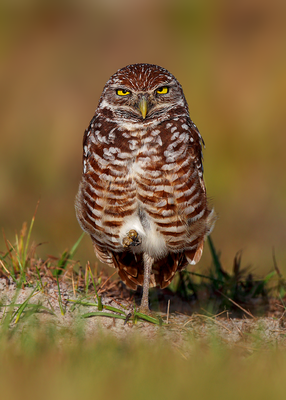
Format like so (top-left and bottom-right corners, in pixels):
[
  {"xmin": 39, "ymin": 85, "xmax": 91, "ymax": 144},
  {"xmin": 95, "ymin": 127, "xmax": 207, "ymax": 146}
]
[{"xmin": 0, "ymin": 0, "xmax": 286, "ymax": 274}]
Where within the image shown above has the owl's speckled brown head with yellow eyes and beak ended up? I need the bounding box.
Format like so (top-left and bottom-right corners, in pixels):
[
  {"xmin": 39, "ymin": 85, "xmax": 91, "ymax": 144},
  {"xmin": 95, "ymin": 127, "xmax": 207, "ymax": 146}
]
[{"xmin": 98, "ymin": 64, "xmax": 188, "ymax": 123}]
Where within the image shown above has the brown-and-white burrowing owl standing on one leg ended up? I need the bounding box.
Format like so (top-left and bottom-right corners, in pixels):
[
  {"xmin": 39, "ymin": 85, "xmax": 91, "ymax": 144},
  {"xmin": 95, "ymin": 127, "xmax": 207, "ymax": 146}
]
[{"xmin": 76, "ymin": 64, "xmax": 215, "ymax": 311}]
